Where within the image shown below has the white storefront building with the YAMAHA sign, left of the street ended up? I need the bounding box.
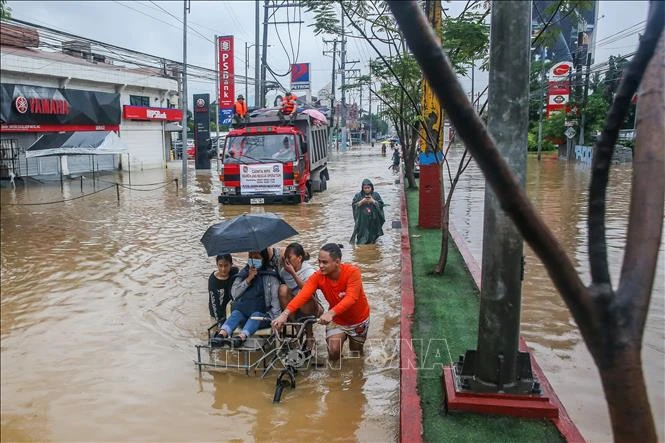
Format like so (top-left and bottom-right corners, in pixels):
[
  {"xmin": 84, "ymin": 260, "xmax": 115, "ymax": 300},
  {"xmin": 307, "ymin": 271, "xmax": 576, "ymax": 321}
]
[{"xmin": 0, "ymin": 27, "xmax": 182, "ymax": 178}]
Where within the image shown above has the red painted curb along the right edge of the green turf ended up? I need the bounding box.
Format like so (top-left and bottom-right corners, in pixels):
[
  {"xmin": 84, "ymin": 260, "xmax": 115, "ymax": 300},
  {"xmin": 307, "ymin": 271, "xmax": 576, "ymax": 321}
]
[{"xmin": 448, "ymin": 223, "xmax": 586, "ymax": 443}]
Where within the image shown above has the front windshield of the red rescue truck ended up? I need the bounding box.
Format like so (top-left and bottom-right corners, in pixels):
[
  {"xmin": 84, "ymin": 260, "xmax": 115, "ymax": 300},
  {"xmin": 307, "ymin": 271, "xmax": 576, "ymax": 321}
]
[{"xmin": 224, "ymin": 134, "xmax": 296, "ymax": 163}]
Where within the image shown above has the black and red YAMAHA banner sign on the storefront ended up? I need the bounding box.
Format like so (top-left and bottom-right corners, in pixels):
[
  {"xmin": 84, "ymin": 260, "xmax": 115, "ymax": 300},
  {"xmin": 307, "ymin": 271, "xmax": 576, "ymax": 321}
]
[{"xmin": 0, "ymin": 83, "xmax": 120, "ymax": 126}]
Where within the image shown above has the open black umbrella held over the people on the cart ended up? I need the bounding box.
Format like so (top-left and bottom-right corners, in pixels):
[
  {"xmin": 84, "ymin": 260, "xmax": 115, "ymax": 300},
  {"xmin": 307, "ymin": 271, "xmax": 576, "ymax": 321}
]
[{"xmin": 201, "ymin": 212, "xmax": 298, "ymax": 257}]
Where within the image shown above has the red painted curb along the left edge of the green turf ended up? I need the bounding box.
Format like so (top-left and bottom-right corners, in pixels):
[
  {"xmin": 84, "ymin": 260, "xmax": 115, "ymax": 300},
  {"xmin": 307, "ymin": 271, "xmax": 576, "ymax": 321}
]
[{"xmin": 399, "ymin": 184, "xmax": 423, "ymax": 443}]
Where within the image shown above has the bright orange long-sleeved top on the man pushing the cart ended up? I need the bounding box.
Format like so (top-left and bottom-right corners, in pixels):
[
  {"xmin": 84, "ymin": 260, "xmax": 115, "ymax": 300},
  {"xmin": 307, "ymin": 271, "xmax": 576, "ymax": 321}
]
[{"xmin": 286, "ymin": 263, "xmax": 369, "ymax": 326}]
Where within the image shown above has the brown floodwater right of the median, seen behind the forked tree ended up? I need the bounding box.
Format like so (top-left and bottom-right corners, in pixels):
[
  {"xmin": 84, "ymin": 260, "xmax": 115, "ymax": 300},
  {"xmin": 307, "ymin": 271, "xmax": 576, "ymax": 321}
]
[{"xmin": 450, "ymin": 149, "xmax": 665, "ymax": 442}]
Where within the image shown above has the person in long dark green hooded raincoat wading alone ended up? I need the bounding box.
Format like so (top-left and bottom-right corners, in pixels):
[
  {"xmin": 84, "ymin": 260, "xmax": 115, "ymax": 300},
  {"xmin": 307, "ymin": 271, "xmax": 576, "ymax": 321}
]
[{"xmin": 350, "ymin": 179, "xmax": 386, "ymax": 244}]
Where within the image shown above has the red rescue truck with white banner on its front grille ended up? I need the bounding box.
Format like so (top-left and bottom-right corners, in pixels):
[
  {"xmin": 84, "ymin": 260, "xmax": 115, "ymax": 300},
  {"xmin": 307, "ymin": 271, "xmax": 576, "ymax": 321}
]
[{"xmin": 218, "ymin": 114, "xmax": 330, "ymax": 205}]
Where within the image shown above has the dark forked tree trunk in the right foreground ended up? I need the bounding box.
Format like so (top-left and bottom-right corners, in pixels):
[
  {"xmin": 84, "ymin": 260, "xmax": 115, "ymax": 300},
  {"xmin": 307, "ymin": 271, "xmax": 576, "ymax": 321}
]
[{"xmin": 390, "ymin": 0, "xmax": 665, "ymax": 442}]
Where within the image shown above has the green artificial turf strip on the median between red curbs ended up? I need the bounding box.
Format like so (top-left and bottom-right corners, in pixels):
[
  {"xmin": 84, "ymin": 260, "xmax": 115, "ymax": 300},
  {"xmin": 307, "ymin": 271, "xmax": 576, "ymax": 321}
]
[{"xmin": 406, "ymin": 189, "xmax": 563, "ymax": 442}]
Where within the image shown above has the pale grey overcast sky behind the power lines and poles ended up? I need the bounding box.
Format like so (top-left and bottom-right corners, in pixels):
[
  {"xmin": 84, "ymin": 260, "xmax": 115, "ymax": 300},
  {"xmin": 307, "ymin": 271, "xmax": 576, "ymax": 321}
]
[{"xmin": 8, "ymin": 0, "xmax": 648, "ymax": 108}]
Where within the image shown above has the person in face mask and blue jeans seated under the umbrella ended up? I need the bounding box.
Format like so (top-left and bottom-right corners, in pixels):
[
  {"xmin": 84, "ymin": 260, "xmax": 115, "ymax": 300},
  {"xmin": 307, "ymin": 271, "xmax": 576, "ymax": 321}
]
[{"xmin": 218, "ymin": 249, "xmax": 282, "ymax": 348}]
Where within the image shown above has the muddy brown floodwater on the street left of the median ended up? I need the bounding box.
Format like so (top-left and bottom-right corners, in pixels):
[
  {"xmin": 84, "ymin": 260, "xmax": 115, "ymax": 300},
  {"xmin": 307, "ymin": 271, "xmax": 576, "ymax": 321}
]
[{"xmin": 1, "ymin": 148, "xmax": 400, "ymax": 441}]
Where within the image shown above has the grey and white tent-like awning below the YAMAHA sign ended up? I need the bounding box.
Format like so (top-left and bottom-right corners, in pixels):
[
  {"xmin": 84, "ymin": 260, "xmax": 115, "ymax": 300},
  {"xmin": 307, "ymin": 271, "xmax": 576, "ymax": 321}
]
[{"xmin": 25, "ymin": 131, "xmax": 128, "ymax": 157}]
